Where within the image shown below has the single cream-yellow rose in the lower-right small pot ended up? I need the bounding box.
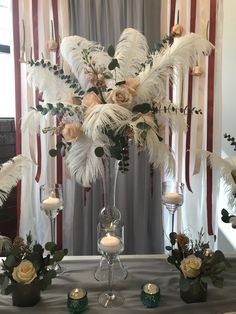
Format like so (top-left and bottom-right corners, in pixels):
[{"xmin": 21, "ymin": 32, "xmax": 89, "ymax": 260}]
[{"xmin": 180, "ymin": 255, "xmax": 202, "ymax": 278}]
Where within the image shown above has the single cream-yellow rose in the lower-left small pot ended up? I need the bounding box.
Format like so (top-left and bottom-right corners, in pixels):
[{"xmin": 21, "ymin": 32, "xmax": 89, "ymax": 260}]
[{"xmin": 12, "ymin": 259, "xmax": 37, "ymax": 285}]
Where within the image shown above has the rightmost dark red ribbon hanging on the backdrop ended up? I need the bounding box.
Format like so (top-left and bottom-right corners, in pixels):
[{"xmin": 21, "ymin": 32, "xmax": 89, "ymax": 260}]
[{"xmin": 207, "ymin": 0, "xmax": 216, "ymax": 235}]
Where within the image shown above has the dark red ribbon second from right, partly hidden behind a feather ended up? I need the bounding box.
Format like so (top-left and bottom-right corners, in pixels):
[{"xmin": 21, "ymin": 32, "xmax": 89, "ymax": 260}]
[{"xmin": 185, "ymin": 0, "xmax": 197, "ymax": 192}]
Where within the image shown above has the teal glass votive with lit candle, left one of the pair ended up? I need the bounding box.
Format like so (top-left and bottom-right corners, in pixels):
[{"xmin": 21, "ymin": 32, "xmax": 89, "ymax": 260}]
[{"xmin": 67, "ymin": 288, "xmax": 88, "ymax": 314}]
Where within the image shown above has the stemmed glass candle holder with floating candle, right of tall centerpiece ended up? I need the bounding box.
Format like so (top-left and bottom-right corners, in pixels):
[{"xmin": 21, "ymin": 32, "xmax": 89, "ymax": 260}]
[{"xmin": 162, "ymin": 181, "xmax": 184, "ymax": 232}]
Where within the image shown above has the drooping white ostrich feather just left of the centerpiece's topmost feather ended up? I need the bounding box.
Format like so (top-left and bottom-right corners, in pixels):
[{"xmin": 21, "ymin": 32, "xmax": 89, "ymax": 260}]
[{"xmin": 61, "ymin": 36, "xmax": 111, "ymax": 91}]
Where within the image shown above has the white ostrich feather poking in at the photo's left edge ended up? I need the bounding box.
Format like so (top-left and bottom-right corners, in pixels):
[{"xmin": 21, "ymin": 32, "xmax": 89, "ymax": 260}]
[{"xmin": 0, "ymin": 155, "xmax": 31, "ymax": 207}]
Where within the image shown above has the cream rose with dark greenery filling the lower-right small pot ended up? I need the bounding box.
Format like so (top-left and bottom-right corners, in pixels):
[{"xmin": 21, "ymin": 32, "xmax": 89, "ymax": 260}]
[{"xmin": 166, "ymin": 229, "xmax": 230, "ymax": 290}]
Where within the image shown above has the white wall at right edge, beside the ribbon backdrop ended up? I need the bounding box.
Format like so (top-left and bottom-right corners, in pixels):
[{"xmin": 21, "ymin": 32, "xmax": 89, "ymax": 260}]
[{"xmin": 218, "ymin": 0, "xmax": 236, "ymax": 253}]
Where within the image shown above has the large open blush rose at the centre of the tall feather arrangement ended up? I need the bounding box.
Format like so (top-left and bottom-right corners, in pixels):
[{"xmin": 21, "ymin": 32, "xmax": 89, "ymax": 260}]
[{"xmin": 107, "ymin": 85, "xmax": 134, "ymax": 109}]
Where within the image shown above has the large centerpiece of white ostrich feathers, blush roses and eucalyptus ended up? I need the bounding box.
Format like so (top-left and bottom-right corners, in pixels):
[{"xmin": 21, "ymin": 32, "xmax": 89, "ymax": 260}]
[{"xmin": 22, "ymin": 28, "xmax": 212, "ymax": 186}]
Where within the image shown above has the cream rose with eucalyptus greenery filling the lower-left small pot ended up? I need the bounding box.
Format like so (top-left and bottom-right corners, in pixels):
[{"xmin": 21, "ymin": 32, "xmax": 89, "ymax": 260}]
[{"xmin": 0, "ymin": 233, "xmax": 67, "ymax": 294}]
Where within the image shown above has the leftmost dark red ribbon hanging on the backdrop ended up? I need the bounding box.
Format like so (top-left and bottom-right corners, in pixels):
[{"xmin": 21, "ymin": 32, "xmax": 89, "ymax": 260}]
[{"xmin": 12, "ymin": 0, "xmax": 21, "ymax": 235}]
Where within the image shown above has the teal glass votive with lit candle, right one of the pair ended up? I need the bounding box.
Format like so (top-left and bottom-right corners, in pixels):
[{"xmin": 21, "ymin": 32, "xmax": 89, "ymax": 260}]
[{"xmin": 141, "ymin": 282, "xmax": 160, "ymax": 307}]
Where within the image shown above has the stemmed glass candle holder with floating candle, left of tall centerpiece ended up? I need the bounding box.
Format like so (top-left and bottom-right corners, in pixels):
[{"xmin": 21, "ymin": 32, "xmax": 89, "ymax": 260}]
[{"xmin": 40, "ymin": 184, "xmax": 64, "ymax": 274}]
